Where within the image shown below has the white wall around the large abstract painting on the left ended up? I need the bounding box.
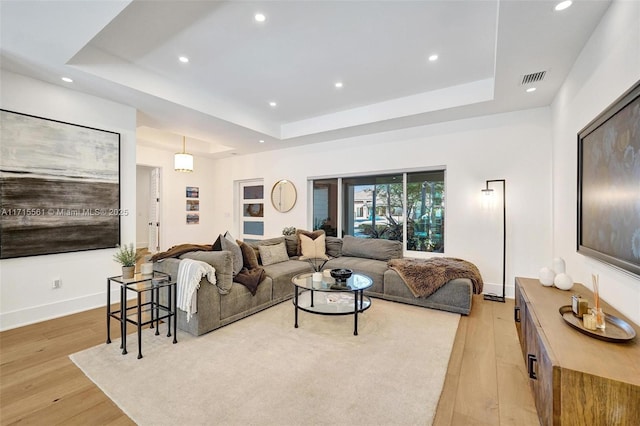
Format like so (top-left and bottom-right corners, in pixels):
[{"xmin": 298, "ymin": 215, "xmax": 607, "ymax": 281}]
[{"xmin": 0, "ymin": 70, "xmax": 136, "ymax": 330}]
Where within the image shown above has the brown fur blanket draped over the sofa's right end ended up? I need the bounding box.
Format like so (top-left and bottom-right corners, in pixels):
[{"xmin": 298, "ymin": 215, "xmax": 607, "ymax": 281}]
[{"xmin": 388, "ymin": 257, "xmax": 483, "ymax": 297}]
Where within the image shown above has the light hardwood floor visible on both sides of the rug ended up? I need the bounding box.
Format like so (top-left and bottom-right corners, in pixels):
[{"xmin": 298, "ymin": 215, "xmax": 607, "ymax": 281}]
[{"xmin": 0, "ymin": 296, "xmax": 539, "ymax": 426}]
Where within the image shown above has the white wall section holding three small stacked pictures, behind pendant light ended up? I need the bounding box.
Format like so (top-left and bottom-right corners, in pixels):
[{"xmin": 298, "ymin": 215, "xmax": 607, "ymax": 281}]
[{"xmin": 137, "ymin": 145, "xmax": 224, "ymax": 250}]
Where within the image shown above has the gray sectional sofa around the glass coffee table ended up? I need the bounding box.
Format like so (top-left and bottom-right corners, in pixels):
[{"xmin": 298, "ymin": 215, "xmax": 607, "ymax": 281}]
[{"xmin": 154, "ymin": 236, "xmax": 473, "ymax": 336}]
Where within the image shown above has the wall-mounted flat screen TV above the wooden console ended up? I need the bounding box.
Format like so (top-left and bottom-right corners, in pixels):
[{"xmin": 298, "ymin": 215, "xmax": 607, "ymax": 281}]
[{"xmin": 577, "ymin": 82, "xmax": 640, "ymax": 277}]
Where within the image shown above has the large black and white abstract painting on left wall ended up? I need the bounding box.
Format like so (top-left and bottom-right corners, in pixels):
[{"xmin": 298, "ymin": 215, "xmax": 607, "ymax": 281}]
[{"xmin": 0, "ymin": 110, "xmax": 120, "ymax": 259}]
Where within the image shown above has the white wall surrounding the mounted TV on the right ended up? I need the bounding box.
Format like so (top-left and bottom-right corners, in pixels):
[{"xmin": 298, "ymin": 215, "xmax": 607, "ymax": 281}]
[{"xmin": 552, "ymin": 1, "xmax": 640, "ymax": 323}]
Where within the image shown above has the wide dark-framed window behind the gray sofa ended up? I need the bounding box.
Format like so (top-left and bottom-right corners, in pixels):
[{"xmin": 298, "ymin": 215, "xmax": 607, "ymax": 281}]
[{"xmin": 313, "ymin": 170, "xmax": 445, "ymax": 253}]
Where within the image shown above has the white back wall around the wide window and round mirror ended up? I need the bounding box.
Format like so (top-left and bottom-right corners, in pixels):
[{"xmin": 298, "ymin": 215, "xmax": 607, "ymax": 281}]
[{"xmin": 212, "ymin": 108, "xmax": 552, "ymax": 295}]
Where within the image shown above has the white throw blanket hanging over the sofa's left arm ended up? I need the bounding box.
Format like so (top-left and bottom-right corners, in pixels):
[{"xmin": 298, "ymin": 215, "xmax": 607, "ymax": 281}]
[{"xmin": 176, "ymin": 259, "xmax": 216, "ymax": 322}]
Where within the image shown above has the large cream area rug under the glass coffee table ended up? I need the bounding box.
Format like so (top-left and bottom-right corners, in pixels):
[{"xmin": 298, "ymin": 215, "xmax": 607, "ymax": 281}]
[{"xmin": 70, "ymin": 299, "xmax": 460, "ymax": 425}]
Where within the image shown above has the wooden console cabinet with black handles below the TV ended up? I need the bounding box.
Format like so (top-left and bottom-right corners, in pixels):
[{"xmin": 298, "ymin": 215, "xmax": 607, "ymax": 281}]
[{"xmin": 514, "ymin": 277, "xmax": 640, "ymax": 426}]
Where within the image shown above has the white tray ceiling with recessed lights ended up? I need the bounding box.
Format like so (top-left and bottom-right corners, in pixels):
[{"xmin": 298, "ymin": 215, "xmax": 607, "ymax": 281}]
[{"xmin": 0, "ymin": 0, "xmax": 610, "ymax": 158}]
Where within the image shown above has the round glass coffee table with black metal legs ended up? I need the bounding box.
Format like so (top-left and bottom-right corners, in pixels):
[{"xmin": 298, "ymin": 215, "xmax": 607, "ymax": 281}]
[{"xmin": 291, "ymin": 273, "xmax": 373, "ymax": 336}]
